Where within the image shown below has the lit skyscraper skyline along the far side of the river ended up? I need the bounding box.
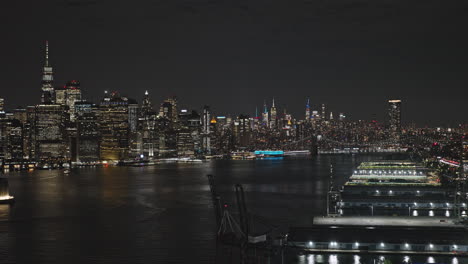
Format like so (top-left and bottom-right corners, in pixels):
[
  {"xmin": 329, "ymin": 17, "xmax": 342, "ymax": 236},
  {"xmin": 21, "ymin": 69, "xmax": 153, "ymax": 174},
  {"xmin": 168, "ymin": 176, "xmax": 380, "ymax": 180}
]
[{"xmin": 0, "ymin": 43, "xmax": 401, "ymax": 167}]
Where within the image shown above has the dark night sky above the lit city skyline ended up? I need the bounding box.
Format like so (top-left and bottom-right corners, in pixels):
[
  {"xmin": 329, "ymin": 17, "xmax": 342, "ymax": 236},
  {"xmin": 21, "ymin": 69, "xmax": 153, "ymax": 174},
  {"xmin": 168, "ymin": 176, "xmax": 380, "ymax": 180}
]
[{"xmin": 0, "ymin": 0, "xmax": 468, "ymax": 126}]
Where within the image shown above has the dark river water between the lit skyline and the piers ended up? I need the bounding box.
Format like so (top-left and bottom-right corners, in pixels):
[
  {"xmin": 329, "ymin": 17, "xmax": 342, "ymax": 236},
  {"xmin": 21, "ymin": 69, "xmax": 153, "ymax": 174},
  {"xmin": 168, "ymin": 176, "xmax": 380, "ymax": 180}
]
[{"xmin": 0, "ymin": 155, "xmax": 462, "ymax": 264}]
